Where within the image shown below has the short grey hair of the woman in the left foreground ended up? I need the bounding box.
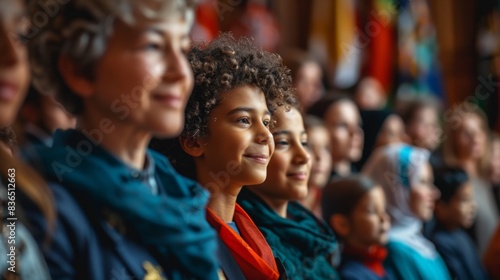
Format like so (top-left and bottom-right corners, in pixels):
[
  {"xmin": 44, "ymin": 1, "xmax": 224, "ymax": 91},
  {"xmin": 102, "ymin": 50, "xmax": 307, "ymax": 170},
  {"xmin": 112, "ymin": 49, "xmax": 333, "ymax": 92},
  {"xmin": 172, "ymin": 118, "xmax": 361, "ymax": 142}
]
[{"xmin": 26, "ymin": 0, "xmax": 196, "ymax": 115}]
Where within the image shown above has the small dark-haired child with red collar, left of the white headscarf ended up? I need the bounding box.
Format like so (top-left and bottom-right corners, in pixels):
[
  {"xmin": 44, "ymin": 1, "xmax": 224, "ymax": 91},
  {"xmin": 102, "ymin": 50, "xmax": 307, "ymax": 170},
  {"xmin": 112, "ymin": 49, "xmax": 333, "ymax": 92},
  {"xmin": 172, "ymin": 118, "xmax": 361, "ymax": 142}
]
[{"xmin": 322, "ymin": 175, "xmax": 394, "ymax": 280}]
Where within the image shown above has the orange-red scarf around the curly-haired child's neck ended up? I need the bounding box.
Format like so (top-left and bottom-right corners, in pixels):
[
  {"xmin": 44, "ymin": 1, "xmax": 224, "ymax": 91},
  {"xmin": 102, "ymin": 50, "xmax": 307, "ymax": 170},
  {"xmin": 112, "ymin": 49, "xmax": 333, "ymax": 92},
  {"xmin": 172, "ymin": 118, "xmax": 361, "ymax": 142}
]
[{"xmin": 207, "ymin": 204, "xmax": 279, "ymax": 280}]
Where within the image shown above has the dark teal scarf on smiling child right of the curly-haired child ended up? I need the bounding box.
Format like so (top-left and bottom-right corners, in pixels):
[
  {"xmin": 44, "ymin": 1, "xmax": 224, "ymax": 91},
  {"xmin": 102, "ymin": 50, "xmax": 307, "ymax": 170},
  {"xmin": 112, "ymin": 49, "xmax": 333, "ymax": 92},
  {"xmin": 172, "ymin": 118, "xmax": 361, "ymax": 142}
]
[{"xmin": 238, "ymin": 187, "xmax": 339, "ymax": 279}]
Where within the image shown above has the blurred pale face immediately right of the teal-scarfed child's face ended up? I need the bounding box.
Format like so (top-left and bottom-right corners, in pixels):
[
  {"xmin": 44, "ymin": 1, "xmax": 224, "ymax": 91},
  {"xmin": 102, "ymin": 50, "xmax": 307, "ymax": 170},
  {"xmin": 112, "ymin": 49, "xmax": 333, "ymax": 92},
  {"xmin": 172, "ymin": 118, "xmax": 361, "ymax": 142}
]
[{"xmin": 307, "ymin": 126, "xmax": 332, "ymax": 188}]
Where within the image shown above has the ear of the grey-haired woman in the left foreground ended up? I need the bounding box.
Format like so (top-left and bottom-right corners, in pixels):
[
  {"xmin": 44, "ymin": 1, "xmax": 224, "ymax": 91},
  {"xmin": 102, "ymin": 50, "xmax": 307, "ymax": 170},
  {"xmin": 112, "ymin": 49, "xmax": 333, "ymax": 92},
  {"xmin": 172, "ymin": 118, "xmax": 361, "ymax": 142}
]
[{"xmin": 57, "ymin": 56, "xmax": 94, "ymax": 98}]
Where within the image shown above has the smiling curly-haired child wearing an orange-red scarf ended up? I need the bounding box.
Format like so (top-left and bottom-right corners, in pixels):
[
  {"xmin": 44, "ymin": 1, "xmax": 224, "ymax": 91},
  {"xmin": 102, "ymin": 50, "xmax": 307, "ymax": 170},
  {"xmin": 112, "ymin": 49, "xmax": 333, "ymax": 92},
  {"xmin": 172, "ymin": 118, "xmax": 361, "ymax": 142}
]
[{"xmin": 160, "ymin": 34, "xmax": 295, "ymax": 279}]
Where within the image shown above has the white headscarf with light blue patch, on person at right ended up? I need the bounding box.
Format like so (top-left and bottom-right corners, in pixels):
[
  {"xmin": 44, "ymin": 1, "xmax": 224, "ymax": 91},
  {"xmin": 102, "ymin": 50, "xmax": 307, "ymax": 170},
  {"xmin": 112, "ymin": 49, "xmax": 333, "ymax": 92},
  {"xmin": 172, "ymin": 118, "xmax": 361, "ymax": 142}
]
[{"xmin": 362, "ymin": 144, "xmax": 436, "ymax": 258}]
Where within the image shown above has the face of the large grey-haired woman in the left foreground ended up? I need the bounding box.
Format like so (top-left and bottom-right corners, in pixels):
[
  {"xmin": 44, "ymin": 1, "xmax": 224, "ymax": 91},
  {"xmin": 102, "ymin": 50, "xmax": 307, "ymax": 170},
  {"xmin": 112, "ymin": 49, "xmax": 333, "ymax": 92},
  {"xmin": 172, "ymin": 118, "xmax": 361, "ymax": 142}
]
[{"xmin": 80, "ymin": 19, "xmax": 193, "ymax": 136}]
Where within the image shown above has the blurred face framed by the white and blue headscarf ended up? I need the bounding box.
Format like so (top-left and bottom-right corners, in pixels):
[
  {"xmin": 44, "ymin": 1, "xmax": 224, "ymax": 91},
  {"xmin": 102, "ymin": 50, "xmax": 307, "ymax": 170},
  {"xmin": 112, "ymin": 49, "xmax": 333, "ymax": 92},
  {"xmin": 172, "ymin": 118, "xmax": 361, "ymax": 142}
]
[{"xmin": 410, "ymin": 163, "xmax": 440, "ymax": 221}]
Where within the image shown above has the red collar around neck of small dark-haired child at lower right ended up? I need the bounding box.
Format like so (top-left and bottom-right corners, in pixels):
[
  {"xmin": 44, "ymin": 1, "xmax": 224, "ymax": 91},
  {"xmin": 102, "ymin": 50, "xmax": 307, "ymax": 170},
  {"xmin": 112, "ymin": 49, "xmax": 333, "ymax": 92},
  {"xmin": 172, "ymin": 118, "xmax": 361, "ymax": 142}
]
[{"xmin": 342, "ymin": 245, "xmax": 387, "ymax": 277}]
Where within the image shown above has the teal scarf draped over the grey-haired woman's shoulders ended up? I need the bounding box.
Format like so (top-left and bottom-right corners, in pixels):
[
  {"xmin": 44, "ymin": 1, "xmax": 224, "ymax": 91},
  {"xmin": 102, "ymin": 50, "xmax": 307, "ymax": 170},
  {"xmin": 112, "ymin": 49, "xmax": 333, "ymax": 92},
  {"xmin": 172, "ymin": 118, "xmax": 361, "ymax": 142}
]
[{"xmin": 27, "ymin": 130, "xmax": 218, "ymax": 280}]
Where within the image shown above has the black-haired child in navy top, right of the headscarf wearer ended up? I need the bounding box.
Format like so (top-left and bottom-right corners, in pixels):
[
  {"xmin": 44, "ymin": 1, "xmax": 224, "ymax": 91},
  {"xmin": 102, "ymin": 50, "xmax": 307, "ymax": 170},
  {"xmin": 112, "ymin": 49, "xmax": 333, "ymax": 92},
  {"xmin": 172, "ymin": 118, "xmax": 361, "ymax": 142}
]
[{"xmin": 429, "ymin": 167, "xmax": 487, "ymax": 280}]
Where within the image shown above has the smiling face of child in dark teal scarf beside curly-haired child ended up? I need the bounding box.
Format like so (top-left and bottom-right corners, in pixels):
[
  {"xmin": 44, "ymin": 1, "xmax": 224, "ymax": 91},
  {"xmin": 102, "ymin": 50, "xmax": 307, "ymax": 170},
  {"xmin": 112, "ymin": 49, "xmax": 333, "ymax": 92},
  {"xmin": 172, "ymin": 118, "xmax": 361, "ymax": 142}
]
[{"xmin": 251, "ymin": 108, "xmax": 311, "ymax": 200}]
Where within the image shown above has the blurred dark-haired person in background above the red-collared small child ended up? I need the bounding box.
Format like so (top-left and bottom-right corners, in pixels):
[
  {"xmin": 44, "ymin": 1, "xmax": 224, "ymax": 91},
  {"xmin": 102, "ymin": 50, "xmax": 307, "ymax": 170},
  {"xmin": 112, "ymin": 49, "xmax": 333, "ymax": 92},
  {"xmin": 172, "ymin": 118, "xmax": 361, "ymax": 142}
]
[{"xmin": 308, "ymin": 94, "xmax": 364, "ymax": 178}]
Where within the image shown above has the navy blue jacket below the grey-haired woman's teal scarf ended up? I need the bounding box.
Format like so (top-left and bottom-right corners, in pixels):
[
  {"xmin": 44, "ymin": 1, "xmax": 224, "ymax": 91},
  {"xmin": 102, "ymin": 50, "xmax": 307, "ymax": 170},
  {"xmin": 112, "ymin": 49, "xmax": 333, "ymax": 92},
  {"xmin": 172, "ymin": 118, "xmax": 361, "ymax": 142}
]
[{"xmin": 23, "ymin": 184, "xmax": 165, "ymax": 280}]
